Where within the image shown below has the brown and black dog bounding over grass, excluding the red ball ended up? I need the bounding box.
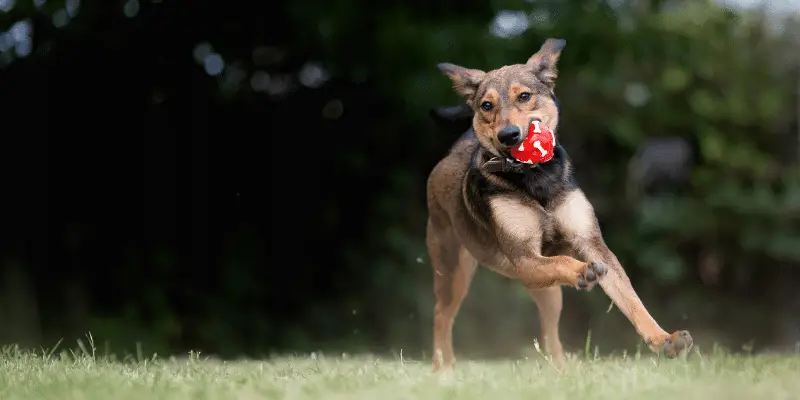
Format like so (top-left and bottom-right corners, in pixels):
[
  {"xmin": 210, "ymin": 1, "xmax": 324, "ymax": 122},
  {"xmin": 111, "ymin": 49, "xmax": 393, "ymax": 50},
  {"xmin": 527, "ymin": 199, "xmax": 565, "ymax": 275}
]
[{"xmin": 426, "ymin": 39, "xmax": 692, "ymax": 370}]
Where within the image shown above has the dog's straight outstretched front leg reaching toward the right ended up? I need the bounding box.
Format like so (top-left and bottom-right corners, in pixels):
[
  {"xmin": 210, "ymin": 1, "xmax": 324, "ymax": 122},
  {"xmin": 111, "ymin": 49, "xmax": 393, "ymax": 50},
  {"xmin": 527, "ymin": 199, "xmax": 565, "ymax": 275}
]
[{"xmin": 553, "ymin": 189, "xmax": 692, "ymax": 358}]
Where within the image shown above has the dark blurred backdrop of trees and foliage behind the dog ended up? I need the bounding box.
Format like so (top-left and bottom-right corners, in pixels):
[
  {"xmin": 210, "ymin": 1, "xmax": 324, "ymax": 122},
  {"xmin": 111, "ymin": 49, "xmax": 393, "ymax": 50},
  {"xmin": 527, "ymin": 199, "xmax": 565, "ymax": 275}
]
[{"xmin": 0, "ymin": 0, "xmax": 800, "ymax": 357}]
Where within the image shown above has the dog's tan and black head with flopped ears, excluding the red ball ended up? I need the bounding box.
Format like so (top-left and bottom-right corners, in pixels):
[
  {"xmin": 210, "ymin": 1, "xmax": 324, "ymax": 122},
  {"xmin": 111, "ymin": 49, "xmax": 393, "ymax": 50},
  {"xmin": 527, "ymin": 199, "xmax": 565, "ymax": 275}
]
[{"xmin": 438, "ymin": 39, "xmax": 567, "ymax": 157}]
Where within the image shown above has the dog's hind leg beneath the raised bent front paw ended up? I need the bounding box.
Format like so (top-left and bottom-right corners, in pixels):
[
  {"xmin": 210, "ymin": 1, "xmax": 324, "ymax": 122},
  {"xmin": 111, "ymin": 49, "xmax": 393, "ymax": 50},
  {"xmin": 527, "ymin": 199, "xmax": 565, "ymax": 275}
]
[{"xmin": 530, "ymin": 286, "xmax": 565, "ymax": 368}]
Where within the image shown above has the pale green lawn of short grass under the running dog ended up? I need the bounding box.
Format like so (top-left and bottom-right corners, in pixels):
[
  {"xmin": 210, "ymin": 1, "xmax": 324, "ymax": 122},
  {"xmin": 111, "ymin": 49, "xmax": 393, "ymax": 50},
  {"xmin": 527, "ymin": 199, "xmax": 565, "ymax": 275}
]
[{"xmin": 0, "ymin": 351, "xmax": 800, "ymax": 400}]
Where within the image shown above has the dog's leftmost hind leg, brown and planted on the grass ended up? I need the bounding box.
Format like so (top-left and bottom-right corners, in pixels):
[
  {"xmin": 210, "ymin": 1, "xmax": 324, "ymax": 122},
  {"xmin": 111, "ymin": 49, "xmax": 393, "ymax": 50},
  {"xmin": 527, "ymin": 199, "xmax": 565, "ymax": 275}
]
[{"xmin": 426, "ymin": 221, "xmax": 478, "ymax": 371}]
